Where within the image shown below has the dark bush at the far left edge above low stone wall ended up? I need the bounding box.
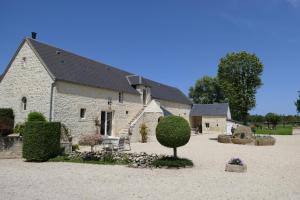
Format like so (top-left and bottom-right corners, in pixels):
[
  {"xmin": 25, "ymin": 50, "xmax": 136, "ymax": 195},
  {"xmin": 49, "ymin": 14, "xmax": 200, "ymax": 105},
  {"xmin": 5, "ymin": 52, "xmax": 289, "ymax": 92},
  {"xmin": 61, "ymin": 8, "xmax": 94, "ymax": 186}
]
[{"xmin": 0, "ymin": 108, "xmax": 15, "ymax": 136}]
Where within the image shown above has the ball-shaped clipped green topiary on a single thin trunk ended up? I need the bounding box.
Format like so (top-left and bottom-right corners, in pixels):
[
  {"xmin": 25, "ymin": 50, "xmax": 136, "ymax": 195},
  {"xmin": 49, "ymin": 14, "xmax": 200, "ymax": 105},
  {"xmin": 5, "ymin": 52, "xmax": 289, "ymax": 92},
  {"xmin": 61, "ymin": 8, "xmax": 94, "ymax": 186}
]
[{"xmin": 156, "ymin": 116, "xmax": 191, "ymax": 158}]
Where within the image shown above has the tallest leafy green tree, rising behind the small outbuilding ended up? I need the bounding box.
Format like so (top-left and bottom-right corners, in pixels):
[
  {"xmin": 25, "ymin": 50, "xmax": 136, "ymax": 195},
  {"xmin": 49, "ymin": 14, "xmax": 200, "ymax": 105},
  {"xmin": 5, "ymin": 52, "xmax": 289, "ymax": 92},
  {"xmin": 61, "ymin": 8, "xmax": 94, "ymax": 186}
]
[{"xmin": 218, "ymin": 51, "xmax": 263, "ymax": 123}]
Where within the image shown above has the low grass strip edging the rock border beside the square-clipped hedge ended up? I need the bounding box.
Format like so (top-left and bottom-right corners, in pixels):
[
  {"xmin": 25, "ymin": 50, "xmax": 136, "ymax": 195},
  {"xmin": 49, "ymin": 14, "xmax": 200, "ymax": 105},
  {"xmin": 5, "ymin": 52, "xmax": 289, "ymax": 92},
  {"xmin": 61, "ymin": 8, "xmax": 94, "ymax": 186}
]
[{"xmin": 48, "ymin": 156, "xmax": 128, "ymax": 165}]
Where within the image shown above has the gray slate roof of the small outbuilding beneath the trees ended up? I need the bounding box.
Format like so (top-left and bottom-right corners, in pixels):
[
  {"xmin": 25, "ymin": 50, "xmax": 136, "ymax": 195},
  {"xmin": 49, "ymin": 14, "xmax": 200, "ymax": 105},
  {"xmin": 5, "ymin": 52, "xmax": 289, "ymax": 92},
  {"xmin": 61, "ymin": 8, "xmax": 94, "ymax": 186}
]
[{"xmin": 190, "ymin": 103, "xmax": 229, "ymax": 116}]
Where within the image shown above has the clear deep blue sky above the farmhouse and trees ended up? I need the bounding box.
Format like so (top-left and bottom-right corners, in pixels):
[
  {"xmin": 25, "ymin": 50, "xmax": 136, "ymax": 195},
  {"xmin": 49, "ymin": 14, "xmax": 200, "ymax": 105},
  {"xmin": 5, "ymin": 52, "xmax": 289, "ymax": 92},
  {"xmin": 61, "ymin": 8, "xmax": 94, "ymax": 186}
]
[{"xmin": 0, "ymin": 0, "xmax": 300, "ymax": 114}]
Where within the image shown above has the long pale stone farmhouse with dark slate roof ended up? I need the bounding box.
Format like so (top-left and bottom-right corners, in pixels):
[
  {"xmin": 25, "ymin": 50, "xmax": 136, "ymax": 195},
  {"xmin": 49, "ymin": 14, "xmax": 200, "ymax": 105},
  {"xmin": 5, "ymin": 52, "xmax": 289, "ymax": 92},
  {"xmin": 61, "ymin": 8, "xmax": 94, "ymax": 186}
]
[{"xmin": 0, "ymin": 38, "xmax": 192, "ymax": 143}]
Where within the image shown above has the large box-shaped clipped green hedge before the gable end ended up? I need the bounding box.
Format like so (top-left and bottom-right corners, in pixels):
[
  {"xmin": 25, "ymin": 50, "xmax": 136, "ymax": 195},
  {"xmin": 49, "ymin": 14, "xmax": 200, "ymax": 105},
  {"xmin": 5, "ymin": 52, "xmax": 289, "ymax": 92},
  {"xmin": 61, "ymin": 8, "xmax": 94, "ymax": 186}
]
[{"xmin": 23, "ymin": 122, "xmax": 61, "ymax": 162}]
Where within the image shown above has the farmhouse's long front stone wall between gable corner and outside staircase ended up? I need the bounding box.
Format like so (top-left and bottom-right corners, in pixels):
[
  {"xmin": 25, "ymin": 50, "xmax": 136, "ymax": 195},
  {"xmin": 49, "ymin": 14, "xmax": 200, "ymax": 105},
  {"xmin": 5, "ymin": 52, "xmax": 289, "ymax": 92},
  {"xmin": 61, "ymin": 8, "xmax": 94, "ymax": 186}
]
[{"xmin": 53, "ymin": 82, "xmax": 143, "ymax": 143}]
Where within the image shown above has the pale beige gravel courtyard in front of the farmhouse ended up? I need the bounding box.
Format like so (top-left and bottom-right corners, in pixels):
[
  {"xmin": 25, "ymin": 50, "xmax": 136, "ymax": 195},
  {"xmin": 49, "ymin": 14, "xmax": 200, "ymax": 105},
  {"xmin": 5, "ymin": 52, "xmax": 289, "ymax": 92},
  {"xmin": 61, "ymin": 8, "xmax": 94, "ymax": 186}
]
[{"xmin": 0, "ymin": 135, "xmax": 300, "ymax": 200}]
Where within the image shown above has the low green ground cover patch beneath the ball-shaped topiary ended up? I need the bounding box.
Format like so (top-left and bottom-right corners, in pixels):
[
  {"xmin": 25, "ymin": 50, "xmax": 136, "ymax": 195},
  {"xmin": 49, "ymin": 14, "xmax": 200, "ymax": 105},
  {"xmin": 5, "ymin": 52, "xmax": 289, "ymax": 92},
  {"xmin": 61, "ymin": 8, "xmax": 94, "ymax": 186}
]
[{"xmin": 152, "ymin": 156, "xmax": 194, "ymax": 168}]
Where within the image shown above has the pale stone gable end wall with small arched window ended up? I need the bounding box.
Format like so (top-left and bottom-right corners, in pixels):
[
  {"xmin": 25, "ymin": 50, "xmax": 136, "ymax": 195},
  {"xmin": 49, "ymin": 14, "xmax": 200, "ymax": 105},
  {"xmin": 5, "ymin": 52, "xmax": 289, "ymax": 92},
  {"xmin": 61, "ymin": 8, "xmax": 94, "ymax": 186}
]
[{"xmin": 0, "ymin": 42, "xmax": 53, "ymax": 124}]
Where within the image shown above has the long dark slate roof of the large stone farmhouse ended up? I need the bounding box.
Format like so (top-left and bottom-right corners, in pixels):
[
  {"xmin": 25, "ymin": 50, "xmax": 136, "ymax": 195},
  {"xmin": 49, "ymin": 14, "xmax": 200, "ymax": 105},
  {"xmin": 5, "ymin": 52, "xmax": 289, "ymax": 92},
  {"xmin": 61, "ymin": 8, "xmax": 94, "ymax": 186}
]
[{"xmin": 26, "ymin": 38, "xmax": 192, "ymax": 104}]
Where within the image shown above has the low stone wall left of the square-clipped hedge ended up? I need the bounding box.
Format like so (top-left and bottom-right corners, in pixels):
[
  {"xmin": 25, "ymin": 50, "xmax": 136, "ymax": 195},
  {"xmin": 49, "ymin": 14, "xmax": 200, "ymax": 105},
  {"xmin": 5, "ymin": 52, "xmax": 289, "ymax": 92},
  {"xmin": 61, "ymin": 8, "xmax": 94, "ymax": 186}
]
[{"xmin": 0, "ymin": 136, "xmax": 22, "ymax": 159}]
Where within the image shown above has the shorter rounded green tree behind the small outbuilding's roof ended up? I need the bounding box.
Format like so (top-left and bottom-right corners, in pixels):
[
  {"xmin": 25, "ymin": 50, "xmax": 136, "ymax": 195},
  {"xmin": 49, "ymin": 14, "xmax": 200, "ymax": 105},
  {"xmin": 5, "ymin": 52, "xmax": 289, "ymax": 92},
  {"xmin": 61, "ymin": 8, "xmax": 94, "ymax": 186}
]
[{"xmin": 189, "ymin": 76, "xmax": 225, "ymax": 104}]
